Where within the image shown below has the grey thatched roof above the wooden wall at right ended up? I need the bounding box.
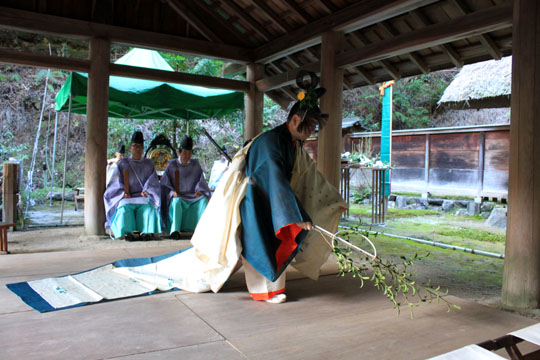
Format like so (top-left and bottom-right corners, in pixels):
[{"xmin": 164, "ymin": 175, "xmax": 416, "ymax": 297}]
[{"xmin": 438, "ymin": 56, "xmax": 512, "ymax": 109}]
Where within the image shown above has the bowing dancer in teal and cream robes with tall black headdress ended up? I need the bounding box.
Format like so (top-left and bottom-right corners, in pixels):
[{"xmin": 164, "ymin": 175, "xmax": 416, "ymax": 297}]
[{"xmin": 190, "ymin": 72, "xmax": 347, "ymax": 304}]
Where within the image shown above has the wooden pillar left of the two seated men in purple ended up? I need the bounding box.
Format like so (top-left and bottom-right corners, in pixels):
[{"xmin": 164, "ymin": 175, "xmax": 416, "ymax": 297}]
[{"xmin": 84, "ymin": 38, "xmax": 111, "ymax": 235}]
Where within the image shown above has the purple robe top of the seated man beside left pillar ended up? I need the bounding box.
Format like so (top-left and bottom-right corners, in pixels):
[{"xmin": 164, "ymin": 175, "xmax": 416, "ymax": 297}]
[{"xmin": 103, "ymin": 157, "xmax": 161, "ymax": 229}]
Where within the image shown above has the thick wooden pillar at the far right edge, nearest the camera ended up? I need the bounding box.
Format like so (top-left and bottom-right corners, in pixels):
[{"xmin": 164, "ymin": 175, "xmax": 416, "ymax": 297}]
[{"xmin": 502, "ymin": 0, "xmax": 540, "ymax": 309}]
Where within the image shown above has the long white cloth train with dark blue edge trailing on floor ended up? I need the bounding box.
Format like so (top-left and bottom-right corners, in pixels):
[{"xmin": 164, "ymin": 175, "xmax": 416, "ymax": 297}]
[{"xmin": 6, "ymin": 248, "xmax": 210, "ymax": 312}]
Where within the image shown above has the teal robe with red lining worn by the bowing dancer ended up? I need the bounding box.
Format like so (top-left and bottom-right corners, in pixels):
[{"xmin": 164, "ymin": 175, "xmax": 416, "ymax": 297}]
[{"xmin": 240, "ymin": 123, "xmax": 311, "ymax": 281}]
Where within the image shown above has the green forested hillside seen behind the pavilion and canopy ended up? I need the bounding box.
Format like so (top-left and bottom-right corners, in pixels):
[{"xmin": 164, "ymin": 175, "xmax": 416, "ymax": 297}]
[{"xmin": 0, "ymin": 48, "xmax": 506, "ymax": 205}]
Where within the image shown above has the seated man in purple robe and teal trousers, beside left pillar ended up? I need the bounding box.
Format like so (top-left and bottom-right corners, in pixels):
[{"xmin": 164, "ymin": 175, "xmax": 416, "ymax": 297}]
[{"xmin": 104, "ymin": 131, "xmax": 161, "ymax": 241}]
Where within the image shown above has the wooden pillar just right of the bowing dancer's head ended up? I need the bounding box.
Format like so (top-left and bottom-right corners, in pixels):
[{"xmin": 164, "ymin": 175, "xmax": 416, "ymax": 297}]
[{"xmin": 317, "ymin": 31, "xmax": 343, "ymax": 188}]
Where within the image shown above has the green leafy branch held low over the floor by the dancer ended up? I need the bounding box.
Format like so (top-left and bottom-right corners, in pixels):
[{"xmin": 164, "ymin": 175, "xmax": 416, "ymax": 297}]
[{"xmin": 333, "ymin": 232, "xmax": 461, "ymax": 318}]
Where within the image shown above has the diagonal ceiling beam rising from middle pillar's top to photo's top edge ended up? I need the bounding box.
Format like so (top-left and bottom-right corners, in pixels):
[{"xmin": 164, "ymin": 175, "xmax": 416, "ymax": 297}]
[{"xmin": 254, "ymin": 0, "xmax": 438, "ymax": 63}]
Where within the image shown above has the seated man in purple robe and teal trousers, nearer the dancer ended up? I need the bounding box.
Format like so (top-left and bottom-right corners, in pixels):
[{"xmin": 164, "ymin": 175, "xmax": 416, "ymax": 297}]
[{"xmin": 161, "ymin": 135, "xmax": 210, "ymax": 239}]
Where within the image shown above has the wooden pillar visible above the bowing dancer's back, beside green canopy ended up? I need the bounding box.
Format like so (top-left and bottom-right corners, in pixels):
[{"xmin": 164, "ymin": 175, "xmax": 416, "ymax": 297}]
[{"xmin": 244, "ymin": 63, "xmax": 264, "ymax": 141}]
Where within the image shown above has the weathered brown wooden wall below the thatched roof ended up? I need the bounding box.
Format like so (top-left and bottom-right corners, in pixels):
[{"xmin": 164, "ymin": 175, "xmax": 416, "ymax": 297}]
[{"xmin": 305, "ymin": 125, "xmax": 510, "ymax": 198}]
